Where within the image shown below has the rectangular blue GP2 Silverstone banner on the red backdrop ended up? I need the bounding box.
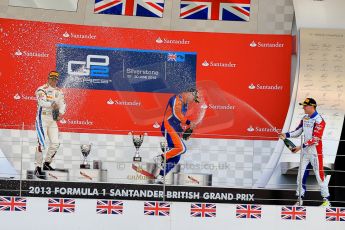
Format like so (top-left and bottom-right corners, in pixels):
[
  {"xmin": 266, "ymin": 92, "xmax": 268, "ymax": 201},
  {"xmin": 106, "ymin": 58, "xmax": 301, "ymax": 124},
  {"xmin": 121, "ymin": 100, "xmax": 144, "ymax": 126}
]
[{"xmin": 56, "ymin": 44, "xmax": 196, "ymax": 93}]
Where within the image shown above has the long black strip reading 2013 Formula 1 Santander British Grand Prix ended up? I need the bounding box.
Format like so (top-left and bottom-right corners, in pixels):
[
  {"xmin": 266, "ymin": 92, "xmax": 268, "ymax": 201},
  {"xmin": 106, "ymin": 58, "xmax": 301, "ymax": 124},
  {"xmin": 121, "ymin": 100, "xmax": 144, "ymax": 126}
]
[{"xmin": 0, "ymin": 180, "xmax": 335, "ymax": 206}]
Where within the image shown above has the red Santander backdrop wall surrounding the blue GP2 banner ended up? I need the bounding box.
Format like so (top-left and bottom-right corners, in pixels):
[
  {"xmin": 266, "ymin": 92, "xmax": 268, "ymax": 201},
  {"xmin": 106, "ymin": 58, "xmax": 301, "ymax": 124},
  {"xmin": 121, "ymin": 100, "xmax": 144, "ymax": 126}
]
[{"xmin": 0, "ymin": 19, "xmax": 292, "ymax": 138}]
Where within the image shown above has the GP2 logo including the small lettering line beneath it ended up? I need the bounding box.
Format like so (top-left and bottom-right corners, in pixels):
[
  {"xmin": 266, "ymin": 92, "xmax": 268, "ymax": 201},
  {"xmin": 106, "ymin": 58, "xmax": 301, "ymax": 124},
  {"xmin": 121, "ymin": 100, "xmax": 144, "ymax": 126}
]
[{"xmin": 68, "ymin": 55, "xmax": 111, "ymax": 84}]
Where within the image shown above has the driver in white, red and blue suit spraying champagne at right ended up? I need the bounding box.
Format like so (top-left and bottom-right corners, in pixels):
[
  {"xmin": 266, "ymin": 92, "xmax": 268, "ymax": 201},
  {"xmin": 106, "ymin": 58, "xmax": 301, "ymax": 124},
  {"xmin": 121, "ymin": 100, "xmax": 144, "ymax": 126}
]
[{"xmin": 279, "ymin": 98, "xmax": 330, "ymax": 206}]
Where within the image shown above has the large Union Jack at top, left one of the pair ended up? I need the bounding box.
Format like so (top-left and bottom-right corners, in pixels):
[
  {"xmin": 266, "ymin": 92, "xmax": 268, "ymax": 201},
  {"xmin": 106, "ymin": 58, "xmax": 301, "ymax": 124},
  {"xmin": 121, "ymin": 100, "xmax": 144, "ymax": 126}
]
[{"xmin": 94, "ymin": 0, "xmax": 165, "ymax": 18}]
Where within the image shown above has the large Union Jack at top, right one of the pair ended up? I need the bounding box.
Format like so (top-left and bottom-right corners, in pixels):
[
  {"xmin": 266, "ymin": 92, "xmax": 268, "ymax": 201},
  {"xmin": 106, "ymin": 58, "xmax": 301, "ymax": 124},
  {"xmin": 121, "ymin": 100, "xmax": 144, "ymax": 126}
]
[{"xmin": 180, "ymin": 0, "xmax": 250, "ymax": 21}]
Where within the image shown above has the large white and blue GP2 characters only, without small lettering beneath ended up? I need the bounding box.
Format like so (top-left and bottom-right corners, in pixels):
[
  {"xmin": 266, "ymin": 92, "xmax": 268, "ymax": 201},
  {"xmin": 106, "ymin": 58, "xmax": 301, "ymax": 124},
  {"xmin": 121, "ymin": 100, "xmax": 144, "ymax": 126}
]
[{"xmin": 68, "ymin": 54, "xmax": 109, "ymax": 78}]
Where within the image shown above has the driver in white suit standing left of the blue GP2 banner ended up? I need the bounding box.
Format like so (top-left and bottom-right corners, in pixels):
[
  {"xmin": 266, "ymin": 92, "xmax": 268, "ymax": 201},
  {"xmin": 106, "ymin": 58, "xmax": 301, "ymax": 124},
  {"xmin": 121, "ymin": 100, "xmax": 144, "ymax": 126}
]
[{"xmin": 34, "ymin": 71, "xmax": 66, "ymax": 179}]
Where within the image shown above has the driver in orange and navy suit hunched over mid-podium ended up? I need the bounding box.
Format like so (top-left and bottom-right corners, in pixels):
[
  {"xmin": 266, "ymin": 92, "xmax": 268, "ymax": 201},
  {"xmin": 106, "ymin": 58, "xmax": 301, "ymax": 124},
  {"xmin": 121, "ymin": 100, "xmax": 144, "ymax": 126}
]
[{"xmin": 154, "ymin": 88, "xmax": 200, "ymax": 183}]
